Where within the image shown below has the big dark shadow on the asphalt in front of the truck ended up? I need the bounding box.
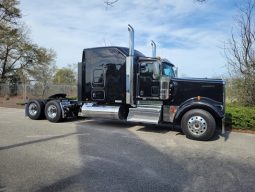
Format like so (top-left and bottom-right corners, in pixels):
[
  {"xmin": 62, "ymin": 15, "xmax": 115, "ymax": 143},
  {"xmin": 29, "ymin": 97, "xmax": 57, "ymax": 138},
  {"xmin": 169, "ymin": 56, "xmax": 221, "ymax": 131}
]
[{"xmin": 36, "ymin": 121, "xmax": 195, "ymax": 192}]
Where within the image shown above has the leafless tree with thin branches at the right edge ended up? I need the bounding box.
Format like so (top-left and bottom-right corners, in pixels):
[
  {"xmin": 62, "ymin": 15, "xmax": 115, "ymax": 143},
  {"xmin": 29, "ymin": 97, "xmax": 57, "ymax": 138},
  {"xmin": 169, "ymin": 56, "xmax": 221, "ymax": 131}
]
[{"xmin": 225, "ymin": 0, "xmax": 255, "ymax": 106}]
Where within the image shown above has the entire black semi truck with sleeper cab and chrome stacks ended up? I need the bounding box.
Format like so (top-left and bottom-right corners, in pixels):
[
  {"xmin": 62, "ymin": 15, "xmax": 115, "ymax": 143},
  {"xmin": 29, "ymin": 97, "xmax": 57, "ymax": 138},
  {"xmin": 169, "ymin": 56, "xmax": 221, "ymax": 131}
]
[{"xmin": 26, "ymin": 25, "xmax": 225, "ymax": 140}]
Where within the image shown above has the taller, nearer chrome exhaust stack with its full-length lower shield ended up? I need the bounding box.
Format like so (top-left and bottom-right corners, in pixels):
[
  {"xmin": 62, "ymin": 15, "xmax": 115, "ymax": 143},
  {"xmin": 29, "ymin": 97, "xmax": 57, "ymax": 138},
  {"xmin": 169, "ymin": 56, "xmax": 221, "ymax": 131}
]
[{"xmin": 126, "ymin": 25, "xmax": 135, "ymax": 106}]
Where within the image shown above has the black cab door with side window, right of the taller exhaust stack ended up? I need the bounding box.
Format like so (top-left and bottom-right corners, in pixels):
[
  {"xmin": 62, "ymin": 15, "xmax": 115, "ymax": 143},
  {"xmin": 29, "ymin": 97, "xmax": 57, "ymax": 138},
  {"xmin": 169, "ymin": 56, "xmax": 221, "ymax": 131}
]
[{"xmin": 137, "ymin": 62, "xmax": 160, "ymax": 99}]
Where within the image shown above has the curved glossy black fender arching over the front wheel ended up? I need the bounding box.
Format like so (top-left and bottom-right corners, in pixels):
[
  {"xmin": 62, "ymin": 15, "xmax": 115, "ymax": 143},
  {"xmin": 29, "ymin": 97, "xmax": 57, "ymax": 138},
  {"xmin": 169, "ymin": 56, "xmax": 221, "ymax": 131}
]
[{"xmin": 174, "ymin": 97, "xmax": 224, "ymax": 122}]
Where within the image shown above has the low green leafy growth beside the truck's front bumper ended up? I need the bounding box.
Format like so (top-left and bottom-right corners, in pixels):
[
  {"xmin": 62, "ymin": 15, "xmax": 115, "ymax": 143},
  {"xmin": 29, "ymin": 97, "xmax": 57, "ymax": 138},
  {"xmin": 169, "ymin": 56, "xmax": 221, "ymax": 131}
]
[{"xmin": 226, "ymin": 104, "xmax": 255, "ymax": 130}]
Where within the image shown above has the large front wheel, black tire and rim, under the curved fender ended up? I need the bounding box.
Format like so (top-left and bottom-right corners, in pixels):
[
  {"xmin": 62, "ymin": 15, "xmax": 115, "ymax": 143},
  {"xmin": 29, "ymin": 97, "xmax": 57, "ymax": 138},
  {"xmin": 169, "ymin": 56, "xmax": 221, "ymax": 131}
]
[{"xmin": 181, "ymin": 109, "xmax": 216, "ymax": 141}]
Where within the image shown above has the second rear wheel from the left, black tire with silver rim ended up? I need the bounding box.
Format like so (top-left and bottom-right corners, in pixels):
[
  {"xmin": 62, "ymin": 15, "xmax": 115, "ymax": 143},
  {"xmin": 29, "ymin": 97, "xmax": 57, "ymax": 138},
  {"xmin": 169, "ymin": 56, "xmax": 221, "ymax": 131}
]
[{"xmin": 44, "ymin": 100, "xmax": 62, "ymax": 123}]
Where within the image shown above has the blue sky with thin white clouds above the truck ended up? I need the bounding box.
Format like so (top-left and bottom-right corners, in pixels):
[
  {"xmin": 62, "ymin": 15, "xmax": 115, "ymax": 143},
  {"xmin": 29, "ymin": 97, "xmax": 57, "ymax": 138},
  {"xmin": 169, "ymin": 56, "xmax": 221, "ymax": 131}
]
[{"xmin": 20, "ymin": 0, "xmax": 241, "ymax": 77}]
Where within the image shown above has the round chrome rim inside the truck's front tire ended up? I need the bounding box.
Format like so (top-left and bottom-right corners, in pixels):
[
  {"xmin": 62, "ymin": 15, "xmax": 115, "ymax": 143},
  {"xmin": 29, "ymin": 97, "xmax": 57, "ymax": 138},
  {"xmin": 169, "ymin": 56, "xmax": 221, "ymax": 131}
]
[{"xmin": 188, "ymin": 116, "xmax": 207, "ymax": 136}]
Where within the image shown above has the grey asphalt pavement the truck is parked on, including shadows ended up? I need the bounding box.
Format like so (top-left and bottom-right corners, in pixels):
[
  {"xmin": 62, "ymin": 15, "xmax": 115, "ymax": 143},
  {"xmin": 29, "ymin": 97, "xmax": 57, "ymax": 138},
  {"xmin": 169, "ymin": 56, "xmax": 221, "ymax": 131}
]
[{"xmin": 0, "ymin": 108, "xmax": 255, "ymax": 192}]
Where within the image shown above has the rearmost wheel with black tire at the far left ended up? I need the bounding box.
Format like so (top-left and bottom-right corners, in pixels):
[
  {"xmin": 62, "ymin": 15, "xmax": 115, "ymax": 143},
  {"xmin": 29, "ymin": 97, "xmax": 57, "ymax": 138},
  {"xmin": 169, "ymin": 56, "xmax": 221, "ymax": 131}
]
[{"xmin": 26, "ymin": 99, "xmax": 44, "ymax": 120}]
